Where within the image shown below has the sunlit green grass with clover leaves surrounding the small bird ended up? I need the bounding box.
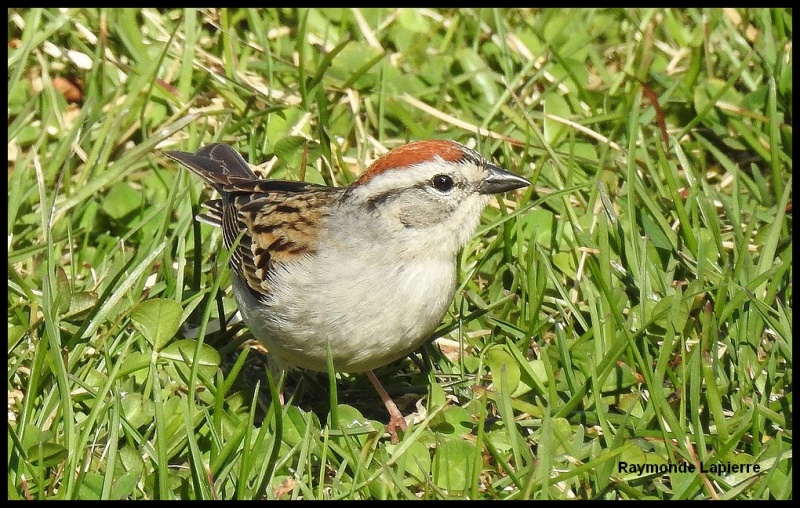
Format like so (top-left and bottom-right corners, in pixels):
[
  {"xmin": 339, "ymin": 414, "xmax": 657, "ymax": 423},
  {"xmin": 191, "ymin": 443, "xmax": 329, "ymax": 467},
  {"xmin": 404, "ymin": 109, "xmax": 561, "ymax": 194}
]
[{"xmin": 7, "ymin": 9, "xmax": 793, "ymax": 499}]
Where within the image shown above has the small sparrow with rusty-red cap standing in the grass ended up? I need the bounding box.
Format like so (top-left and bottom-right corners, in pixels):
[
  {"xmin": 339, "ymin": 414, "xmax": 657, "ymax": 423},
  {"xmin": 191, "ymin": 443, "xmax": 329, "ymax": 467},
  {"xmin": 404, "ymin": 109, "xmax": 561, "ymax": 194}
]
[{"xmin": 165, "ymin": 141, "xmax": 530, "ymax": 441}]
